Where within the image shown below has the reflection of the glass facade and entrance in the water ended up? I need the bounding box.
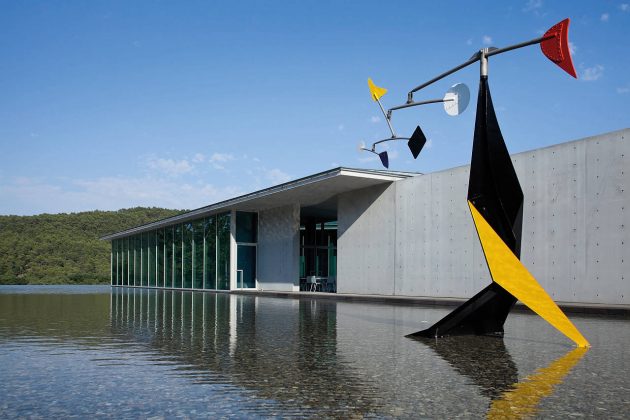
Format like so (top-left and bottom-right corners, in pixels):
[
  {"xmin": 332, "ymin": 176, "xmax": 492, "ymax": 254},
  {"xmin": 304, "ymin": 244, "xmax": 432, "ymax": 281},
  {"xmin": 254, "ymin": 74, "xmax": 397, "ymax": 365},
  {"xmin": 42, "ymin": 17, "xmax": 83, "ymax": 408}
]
[{"xmin": 111, "ymin": 288, "xmax": 377, "ymax": 417}]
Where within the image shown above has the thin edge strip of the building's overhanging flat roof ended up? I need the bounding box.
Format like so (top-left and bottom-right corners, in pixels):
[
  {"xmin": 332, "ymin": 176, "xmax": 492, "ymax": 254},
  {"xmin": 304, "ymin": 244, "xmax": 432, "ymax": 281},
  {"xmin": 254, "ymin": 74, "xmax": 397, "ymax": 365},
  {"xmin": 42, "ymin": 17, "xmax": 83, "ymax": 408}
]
[{"xmin": 99, "ymin": 167, "xmax": 421, "ymax": 241}]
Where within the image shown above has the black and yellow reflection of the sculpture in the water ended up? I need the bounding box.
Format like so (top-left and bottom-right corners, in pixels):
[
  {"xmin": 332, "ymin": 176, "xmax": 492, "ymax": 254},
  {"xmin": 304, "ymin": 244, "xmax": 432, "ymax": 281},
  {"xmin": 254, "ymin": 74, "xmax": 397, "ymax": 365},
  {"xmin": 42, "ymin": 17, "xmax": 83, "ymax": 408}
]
[{"xmin": 423, "ymin": 336, "xmax": 588, "ymax": 419}]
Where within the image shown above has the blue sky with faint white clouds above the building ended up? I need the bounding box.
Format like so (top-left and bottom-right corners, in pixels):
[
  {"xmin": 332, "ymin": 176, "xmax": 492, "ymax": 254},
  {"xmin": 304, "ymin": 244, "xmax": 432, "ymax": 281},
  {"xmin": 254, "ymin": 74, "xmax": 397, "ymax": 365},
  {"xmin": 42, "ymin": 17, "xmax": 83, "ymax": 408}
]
[{"xmin": 0, "ymin": 0, "xmax": 630, "ymax": 215}]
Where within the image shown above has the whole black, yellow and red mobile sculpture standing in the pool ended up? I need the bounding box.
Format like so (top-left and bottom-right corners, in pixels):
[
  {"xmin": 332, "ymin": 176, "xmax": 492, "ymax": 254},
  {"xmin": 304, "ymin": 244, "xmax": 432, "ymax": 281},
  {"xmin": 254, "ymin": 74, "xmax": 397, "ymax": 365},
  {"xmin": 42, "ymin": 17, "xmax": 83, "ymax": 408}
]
[{"xmin": 372, "ymin": 19, "xmax": 589, "ymax": 347}]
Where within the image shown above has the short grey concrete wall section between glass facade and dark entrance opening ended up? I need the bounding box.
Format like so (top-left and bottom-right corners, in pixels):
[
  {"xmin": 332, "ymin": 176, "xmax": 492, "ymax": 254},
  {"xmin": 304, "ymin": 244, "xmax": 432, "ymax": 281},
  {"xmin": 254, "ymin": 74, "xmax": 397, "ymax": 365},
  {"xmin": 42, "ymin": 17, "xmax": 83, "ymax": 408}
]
[{"xmin": 257, "ymin": 204, "xmax": 300, "ymax": 291}]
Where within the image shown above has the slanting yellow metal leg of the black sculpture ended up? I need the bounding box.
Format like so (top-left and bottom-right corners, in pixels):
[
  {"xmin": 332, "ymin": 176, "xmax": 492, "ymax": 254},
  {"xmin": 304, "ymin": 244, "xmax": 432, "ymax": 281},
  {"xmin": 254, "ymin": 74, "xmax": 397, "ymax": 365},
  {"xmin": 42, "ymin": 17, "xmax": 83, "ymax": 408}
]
[{"xmin": 468, "ymin": 201, "xmax": 589, "ymax": 347}]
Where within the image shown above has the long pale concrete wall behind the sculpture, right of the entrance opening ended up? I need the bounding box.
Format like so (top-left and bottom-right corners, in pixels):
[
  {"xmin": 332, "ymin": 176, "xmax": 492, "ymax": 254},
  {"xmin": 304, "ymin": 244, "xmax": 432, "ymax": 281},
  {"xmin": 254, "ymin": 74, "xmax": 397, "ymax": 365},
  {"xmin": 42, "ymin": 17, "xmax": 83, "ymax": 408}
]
[{"xmin": 337, "ymin": 129, "xmax": 630, "ymax": 304}]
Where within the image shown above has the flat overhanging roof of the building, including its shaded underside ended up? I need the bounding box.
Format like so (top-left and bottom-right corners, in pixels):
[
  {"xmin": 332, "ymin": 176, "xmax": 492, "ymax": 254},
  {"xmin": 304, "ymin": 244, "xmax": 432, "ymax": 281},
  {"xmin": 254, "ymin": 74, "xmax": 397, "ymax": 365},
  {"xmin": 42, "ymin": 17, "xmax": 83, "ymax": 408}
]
[{"xmin": 101, "ymin": 167, "xmax": 422, "ymax": 240}]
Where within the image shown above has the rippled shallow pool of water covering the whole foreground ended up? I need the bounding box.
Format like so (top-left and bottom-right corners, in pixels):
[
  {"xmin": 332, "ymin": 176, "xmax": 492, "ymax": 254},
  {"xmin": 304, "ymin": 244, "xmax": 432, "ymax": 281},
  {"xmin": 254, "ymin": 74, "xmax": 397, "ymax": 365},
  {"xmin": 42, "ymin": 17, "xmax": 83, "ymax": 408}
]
[{"xmin": 0, "ymin": 286, "xmax": 630, "ymax": 418}]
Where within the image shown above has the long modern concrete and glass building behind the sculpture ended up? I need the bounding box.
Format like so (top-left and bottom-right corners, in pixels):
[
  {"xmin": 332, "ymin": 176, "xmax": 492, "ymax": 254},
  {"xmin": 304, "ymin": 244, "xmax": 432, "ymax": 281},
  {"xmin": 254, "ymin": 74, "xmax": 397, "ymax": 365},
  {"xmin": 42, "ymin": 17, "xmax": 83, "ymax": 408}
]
[{"xmin": 103, "ymin": 129, "xmax": 630, "ymax": 306}]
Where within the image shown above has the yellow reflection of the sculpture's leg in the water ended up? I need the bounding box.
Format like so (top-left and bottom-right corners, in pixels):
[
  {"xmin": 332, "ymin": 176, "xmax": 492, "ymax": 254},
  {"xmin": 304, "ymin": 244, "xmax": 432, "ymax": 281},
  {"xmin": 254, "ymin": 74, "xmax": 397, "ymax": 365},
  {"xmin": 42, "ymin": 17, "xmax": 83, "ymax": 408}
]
[{"xmin": 487, "ymin": 347, "xmax": 587, "ymax": 419}]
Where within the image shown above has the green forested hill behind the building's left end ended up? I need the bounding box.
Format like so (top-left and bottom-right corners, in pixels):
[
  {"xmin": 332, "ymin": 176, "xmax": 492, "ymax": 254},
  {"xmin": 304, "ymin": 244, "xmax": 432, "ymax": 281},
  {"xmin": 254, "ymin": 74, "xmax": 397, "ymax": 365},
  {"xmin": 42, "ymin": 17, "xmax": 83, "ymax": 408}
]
[{"xmin": 0, "ymin": 207, "xmax": 183, "ymax": 284}]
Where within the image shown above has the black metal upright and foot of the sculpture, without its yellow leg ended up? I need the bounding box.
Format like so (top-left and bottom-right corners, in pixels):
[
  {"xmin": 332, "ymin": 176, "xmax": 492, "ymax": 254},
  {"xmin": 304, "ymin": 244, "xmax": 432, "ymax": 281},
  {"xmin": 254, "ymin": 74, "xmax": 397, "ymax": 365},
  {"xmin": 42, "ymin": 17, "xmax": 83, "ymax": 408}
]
[{"xmin": 408, "ymin": 76, "xmax": 523, "ymax": 337}]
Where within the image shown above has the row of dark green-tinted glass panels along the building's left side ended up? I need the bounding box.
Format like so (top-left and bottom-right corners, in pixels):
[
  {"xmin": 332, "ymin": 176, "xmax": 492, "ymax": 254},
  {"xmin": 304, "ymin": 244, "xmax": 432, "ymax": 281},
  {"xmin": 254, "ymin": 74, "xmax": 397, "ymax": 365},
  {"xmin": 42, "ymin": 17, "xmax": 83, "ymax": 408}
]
[{"xmin": 111, "ymin": 213, "xmax": 235, "ymax": 290}]
